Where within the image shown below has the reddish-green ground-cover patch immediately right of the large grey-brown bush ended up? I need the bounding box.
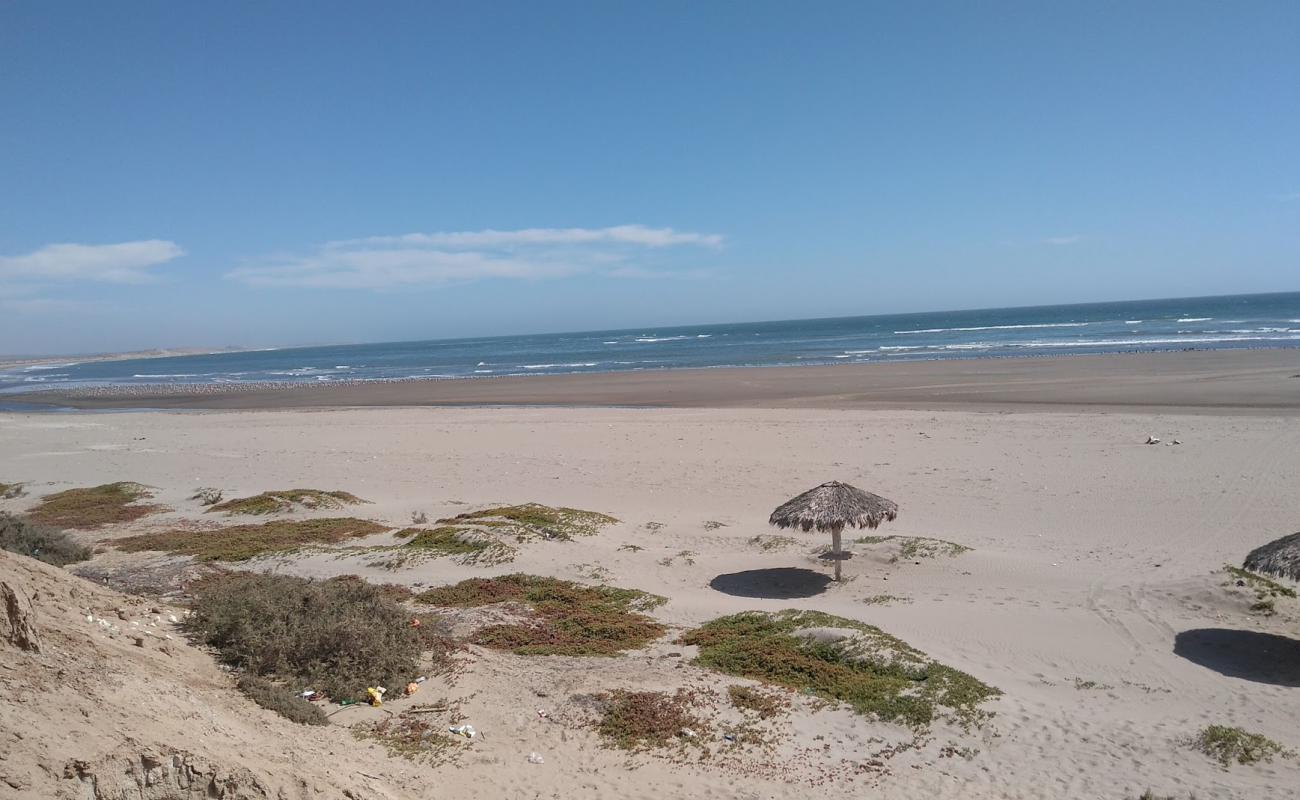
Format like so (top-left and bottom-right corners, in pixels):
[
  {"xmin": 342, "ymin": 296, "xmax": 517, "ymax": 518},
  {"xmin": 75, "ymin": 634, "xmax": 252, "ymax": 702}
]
[{"xmin": 416, "ymin": 574, "xmax": 664, "ymax": 656}]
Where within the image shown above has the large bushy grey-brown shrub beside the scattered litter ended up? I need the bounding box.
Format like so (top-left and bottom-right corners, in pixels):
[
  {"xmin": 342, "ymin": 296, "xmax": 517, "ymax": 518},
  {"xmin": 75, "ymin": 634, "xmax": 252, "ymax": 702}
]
[{"xmin": 185, "ymin": 572, "xmax": 450, "ymax": 700}]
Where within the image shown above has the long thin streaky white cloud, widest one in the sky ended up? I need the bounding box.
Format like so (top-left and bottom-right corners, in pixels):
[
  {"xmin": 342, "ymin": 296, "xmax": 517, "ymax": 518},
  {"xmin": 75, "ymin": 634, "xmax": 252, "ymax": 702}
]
[{"xmin": 226, "ymin": 225, "xmax": 723, "ymax": 290}]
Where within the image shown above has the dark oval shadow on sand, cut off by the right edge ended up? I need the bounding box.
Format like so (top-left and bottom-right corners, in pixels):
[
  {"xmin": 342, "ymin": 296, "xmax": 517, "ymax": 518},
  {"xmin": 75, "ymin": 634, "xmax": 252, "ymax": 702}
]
[{"xmin": 1174, "ymin": 628, "xmax": 1300, "ymax": 687}]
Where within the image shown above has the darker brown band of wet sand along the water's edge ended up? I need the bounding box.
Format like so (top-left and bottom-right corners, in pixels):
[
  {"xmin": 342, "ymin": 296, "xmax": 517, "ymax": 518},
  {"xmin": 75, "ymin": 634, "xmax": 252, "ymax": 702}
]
[{"xmin": 3, "ymin": 349, "xmax": 1300, "ymax": 415}]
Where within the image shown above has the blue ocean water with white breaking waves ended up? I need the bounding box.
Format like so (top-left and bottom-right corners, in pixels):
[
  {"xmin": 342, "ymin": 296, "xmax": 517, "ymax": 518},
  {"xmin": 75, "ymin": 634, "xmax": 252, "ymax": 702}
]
[{"xmin": 0, "ymin": 293, "xmax": 1300, "ymax": 393}]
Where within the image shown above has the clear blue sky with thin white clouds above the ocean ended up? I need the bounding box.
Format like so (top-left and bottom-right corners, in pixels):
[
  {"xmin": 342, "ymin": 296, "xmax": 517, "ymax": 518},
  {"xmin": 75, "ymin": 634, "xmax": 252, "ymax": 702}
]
[{"xmin": 0, "ymin": 1, "xmax": 1300, "ymax": 353}]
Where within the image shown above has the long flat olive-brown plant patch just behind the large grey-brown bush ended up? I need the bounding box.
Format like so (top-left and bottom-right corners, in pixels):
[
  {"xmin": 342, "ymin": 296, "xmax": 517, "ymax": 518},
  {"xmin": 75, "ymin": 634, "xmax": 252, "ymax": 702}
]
[{"xmin": 113, "ymin": 516, "xmax": 387, "ymax": 561}]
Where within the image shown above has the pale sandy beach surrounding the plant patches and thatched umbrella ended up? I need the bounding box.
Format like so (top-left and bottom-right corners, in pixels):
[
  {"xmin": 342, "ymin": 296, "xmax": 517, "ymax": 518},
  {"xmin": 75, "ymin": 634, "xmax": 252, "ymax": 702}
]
[{"xmin": 0, "ymin": 387, "xmax": 1300, "ymax": 799}]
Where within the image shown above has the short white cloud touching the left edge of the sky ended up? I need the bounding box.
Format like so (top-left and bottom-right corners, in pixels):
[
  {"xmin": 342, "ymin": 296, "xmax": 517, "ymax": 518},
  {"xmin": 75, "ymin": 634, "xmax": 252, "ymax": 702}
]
[{"xmin": 0, "ymin": 239, "xmax": 185, "ymax": 284}]
